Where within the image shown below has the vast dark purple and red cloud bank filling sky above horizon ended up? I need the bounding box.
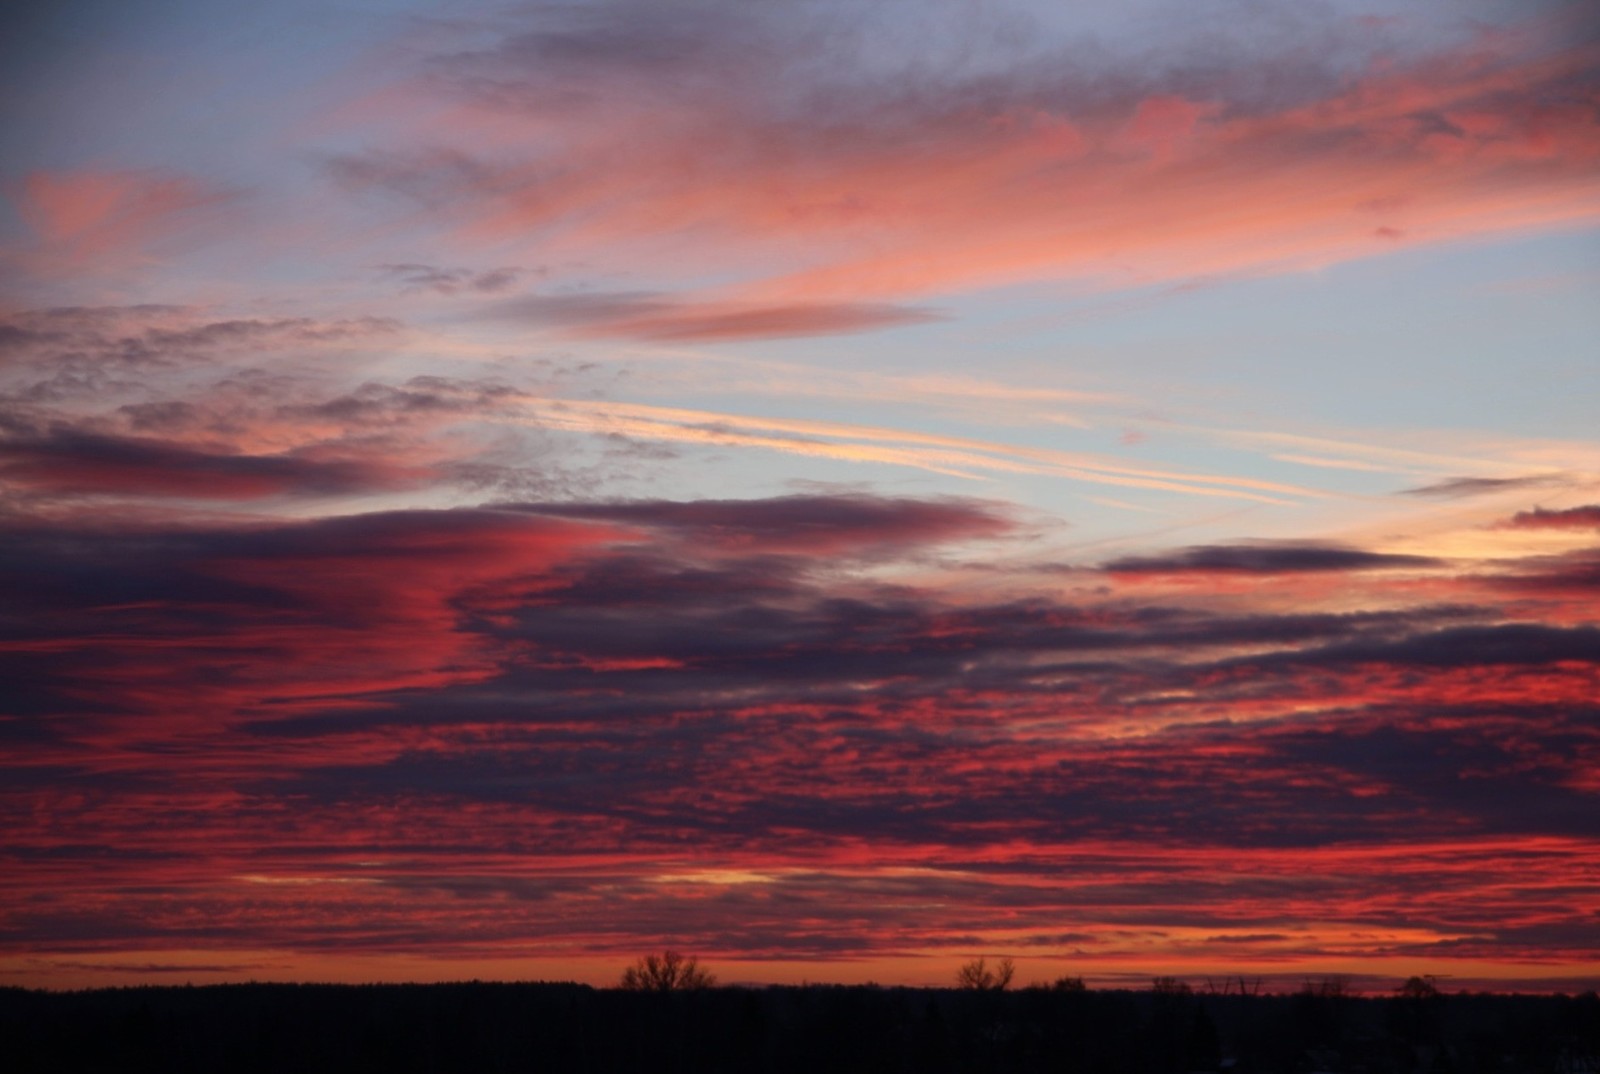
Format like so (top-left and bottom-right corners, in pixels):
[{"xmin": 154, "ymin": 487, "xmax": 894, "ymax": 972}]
[{"xmin": 0, "ymin": 492, "xmax": 1600, "ymax": 957}]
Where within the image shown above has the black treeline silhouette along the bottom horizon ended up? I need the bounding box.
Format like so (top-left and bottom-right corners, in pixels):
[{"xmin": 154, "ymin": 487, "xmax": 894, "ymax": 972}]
[{"xmin": 0, "ymin": 981, "xmax": 1600, "ymax": 1074}]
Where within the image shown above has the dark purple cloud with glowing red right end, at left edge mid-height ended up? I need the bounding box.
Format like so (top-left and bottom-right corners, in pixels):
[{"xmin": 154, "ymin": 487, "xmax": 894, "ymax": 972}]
[{"xmin": 0, "ymin": 511, "xmax": 630, "ymax": 733}]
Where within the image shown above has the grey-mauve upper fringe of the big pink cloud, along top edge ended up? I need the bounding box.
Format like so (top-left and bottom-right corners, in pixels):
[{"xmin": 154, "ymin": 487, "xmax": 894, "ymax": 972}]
[{"xmin": 430, "ymin": 0, "xmax": 1427, "ymax": 129}]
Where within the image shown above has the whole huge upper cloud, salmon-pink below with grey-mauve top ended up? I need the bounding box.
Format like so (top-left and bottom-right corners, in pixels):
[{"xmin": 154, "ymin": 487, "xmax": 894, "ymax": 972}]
[{"xmin": 330, "ymin": 3, "xmax": 1600, "ymax": 308}]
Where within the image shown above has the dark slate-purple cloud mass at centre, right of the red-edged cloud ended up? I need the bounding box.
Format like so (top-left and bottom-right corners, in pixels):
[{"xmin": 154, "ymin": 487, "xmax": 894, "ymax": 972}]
[{"xmin": 236, "ymin": 582, "xmax": 1484, "ymax": 735}]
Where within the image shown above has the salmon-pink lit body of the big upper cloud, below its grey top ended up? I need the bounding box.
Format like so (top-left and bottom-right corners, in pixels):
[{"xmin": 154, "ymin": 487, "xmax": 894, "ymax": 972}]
[{"xmin": 321, "ymin": 21, "xmax": 1600, "ymax": 316}]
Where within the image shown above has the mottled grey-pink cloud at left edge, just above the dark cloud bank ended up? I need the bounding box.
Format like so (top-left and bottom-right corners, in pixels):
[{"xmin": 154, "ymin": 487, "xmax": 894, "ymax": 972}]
[{"xmin": 0, "ymin": 306, "xmax": 651, "ymax": 509}]
